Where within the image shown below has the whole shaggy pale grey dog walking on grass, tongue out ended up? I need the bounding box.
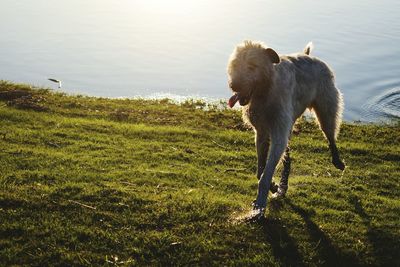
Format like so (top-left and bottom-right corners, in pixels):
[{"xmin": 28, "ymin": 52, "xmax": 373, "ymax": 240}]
[{"xmin": 228, "ymin": 41, "xmax": 345, "ymax": 216}]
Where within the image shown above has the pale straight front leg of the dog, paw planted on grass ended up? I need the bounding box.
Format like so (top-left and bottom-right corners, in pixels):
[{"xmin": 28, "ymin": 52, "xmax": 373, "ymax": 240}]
[{"xmin": 254, "ymin": 132, "xmax": 288, "ymax": 212}]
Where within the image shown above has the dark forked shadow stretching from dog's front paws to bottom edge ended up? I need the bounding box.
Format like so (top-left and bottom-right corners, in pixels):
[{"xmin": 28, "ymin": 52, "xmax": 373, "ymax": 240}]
[{"xmin": 259, "ymin": 198, "xmax": 361, "ymax": 266}]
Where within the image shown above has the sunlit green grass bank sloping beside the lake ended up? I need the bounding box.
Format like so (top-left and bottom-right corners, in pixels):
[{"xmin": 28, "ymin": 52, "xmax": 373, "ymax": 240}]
[{"xmin": 0, "ymin": 81, "xmax": 400, "ymax": 266}]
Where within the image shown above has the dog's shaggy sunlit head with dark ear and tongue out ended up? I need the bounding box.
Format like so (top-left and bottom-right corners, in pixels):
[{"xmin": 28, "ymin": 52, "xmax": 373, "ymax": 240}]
[{"xmin": 228, "ymin": 41, "xmax": 280, "ymax": 107}]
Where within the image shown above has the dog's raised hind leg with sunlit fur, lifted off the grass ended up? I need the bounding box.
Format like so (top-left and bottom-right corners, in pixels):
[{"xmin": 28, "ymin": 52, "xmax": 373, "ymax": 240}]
[{"xmin": 313, "ymin": 86, "xmax": 346, "ymax": 170}]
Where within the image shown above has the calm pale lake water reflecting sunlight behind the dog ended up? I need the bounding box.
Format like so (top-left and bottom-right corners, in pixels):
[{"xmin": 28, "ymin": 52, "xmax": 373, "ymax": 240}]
[{"xmin": 0, "ymin": 0, "xmax": 400, "ymax": 121}]
